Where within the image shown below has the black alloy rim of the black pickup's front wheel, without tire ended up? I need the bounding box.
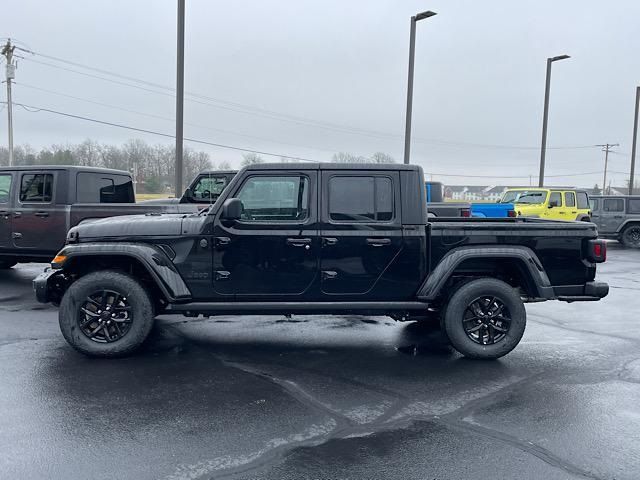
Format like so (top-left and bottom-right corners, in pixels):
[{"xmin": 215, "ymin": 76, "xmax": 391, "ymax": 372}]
[{"xmin": 78, "ymin": 290, "xmax": 133, "ymax": 343}]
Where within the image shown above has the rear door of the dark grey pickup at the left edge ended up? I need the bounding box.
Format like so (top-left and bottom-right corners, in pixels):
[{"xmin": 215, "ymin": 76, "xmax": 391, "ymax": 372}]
[{"xmin": 12, "ymin": 171, "xmax": 66, "ymax": 254}]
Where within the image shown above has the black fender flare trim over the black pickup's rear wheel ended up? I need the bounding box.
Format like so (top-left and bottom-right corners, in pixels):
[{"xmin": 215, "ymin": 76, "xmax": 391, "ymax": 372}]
[{"xmin": 417, "ymin": 245, "xmax": 555, "ymax": 301}]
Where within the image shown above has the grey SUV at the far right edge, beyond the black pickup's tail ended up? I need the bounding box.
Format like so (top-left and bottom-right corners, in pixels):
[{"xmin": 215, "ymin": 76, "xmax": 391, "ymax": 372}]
[{"xmin": 589, "ymin": 195, "xmax": 640, "ymax": 248}]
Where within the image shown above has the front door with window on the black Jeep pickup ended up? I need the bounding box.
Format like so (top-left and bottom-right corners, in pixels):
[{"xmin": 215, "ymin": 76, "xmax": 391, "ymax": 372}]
[{"xmin": 213, "ymin": 170, "xmax": 320, "ymax": 301}]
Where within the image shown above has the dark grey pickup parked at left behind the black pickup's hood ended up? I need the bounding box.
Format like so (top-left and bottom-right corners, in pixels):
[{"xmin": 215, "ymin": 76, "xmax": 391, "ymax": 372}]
[{"xmin": 0, "ymin": 165, "xmax": 196, "ymax": 269}]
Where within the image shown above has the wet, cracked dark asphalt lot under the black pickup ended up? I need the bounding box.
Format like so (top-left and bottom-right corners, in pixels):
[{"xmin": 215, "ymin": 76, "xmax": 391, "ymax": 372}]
[{"xmin": 0, "ymin": 243, "xmax": 640, "ymax": 480}]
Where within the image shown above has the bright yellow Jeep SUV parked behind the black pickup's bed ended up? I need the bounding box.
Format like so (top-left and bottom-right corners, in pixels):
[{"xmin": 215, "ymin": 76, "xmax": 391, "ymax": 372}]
[{"xmin": 500, "ymin": 188, "xmax": 591, "ymax": 222}]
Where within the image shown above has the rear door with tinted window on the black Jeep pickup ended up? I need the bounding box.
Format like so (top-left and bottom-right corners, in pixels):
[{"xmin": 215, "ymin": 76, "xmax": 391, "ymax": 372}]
[{"xmin": 320, "ymin": 170, "xmax": 403, "ymax": 300}]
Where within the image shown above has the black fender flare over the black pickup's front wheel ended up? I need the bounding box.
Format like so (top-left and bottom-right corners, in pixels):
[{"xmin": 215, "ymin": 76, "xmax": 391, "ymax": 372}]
[{"xmin": 58, "ymin": 242, "xmax": 191, "ymax": 302}]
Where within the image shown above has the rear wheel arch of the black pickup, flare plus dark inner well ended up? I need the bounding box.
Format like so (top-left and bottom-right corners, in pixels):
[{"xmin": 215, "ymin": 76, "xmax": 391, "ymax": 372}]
[{"xmin": 417, "ymin": 246, "xmax": 554, "ymax": 302}]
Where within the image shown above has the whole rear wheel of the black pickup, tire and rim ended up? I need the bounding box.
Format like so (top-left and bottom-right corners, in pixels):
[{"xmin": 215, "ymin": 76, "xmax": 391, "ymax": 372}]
[{"xmin": 443, "ymin": 278, "xmax": 527, "ymax": 359}]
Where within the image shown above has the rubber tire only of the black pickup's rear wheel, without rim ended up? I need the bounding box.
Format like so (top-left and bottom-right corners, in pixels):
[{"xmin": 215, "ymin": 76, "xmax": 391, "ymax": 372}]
[{"xmin": 442, "ymin": 278, "xmax": 527, "ymax": 360}]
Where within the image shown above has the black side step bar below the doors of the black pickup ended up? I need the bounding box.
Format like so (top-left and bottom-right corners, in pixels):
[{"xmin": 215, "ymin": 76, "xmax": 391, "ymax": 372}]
[{"xmin": 163, "ymin": 302, "xmax": 427, "ymax": 316}]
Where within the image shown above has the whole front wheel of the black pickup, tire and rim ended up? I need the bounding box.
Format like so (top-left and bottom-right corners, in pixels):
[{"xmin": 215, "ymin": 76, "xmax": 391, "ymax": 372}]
[{"xmin": 59, "ymin": 271, "xmax": 154, "ymax": 357}]
